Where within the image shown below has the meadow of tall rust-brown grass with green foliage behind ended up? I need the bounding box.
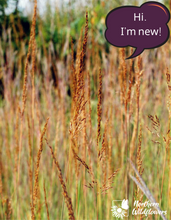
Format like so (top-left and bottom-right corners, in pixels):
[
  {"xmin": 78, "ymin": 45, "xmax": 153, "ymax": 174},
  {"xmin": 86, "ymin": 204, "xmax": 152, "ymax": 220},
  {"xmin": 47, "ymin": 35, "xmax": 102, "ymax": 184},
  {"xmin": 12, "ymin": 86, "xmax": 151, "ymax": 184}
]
[{"xmin": 0, "ymin": 0, "xmax": 171, "ymax": 220}]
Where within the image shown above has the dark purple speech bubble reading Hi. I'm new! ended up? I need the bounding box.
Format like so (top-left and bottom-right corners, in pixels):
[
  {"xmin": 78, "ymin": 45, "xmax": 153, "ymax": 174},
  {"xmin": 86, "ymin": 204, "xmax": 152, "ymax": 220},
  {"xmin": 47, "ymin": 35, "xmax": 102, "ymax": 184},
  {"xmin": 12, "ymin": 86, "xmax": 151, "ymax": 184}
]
[{"xmin": 105, "ymin": 1, "xmax": 170, "ymax": 59}]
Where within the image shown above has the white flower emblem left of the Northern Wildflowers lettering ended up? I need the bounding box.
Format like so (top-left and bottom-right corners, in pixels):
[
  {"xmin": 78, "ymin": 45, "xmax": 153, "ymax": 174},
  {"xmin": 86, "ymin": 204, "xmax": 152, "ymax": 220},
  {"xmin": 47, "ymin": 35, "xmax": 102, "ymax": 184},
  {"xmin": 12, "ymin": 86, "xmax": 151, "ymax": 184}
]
[{"xmin": 111, "ymin": 199, "xmax": 129, "ymax": 219}]
